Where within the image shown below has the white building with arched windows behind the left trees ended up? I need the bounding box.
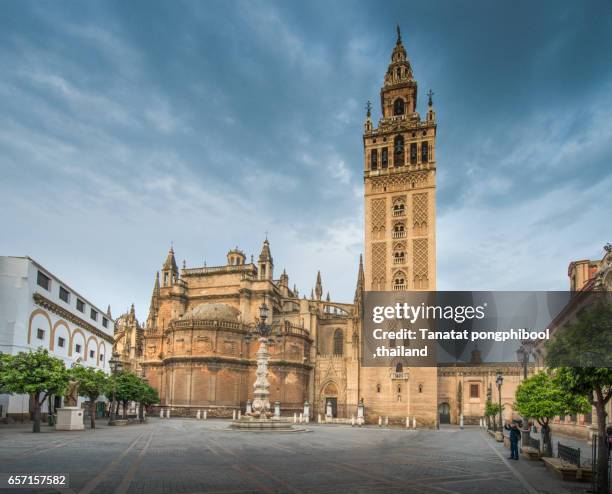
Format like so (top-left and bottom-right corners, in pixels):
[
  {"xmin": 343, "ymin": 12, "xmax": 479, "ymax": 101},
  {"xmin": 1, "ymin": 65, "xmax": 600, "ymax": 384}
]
[{"xmin": 0, "ymin": 256, "xmax": 115, "ymax": 419}]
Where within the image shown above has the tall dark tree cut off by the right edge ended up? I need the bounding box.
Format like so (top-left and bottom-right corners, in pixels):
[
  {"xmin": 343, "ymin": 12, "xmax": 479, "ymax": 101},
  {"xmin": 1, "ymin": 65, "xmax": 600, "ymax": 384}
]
[{"xmin": 546, "ymin": 300, "xmax": 612, "ymax": 493}]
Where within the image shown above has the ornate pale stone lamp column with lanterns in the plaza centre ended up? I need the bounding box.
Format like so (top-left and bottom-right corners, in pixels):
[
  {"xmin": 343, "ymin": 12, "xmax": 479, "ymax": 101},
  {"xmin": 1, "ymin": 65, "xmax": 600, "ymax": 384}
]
[{"xmin": 246, "ymin": 300, "xmax": 283, "ymax": 419}]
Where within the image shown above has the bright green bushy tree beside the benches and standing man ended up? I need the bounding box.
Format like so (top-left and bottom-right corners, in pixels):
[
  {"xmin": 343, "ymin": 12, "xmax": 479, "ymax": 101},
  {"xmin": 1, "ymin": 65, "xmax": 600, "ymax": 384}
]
[{"xmin": 514, "ymin": 372, "xmax": 589, "ymax": 456}]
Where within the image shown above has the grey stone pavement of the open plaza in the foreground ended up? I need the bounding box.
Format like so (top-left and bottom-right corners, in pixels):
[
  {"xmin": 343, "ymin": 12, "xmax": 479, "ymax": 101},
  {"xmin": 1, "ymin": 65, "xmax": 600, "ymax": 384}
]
[{"xmin": 0, "ymin": 418, "xmax": 588, "ymax": 494}]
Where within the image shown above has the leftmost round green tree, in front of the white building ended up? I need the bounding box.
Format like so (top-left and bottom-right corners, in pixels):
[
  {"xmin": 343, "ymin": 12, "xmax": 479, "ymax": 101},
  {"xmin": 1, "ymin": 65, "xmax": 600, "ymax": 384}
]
[{"xmin": 1, "ymin": 348, "xmax": 69, "ymax": 432}]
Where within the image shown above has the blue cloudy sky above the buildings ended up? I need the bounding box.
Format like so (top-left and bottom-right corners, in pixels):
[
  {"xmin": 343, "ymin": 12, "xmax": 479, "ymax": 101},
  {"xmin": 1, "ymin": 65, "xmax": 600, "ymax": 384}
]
[{"xmin": 0, "ymin": 0, "xmax": 612, "ymax": 319}]
